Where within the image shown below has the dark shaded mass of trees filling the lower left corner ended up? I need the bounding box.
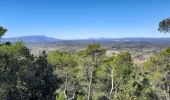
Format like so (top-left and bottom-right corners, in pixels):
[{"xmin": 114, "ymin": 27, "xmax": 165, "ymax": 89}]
[{"xmin": 0, "ymin": 43, "xmax": 61, "ymax": 100}]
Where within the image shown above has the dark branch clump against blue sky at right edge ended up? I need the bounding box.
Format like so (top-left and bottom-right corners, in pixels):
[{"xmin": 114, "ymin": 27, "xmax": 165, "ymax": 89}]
[{"xmin": 158, "ymin": 18, "xmax": 170, "ymax": 33}]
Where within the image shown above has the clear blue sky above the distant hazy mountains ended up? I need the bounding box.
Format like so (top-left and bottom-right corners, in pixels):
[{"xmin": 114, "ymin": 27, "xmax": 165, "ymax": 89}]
[{"xmin": 0, "ymin": 0, "xmax": 170, "ymax": 39}]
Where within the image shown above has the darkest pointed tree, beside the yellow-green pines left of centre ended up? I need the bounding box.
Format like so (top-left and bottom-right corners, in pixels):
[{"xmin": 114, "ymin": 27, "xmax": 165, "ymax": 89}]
[{"xmin": 27, "ymin": 52, "xmax": 61, "ymax": 100}]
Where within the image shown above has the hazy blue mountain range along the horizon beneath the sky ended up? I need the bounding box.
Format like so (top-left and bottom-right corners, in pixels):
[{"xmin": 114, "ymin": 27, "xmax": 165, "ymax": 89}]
[{"xmin": 0, "ymin": 35, "xmax": 170, "ymax": 42}]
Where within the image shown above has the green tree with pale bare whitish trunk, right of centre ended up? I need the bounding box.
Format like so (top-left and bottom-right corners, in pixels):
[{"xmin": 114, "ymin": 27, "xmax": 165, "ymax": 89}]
[{"xmin": 97, "ymin": 52, "xmax": 137, "ymax": 100}]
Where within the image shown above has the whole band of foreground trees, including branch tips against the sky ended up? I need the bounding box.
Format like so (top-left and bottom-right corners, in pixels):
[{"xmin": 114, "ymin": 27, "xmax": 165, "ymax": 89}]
[{"xmin": 0, "ymin": 19, "xmax": 170, "ymax": 100}]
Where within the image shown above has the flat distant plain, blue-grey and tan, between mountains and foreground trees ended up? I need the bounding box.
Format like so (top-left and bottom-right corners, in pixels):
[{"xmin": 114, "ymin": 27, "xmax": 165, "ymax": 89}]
[{"xmin": 21, "ymin": 39, "xmax": 170, "ymax": 64}]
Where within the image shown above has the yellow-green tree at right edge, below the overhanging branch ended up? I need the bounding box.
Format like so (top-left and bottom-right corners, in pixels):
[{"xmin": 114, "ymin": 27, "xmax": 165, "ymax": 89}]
[{"xmin": 144, "ymin": 47, "xmax": 170, "ymax": 100}]
